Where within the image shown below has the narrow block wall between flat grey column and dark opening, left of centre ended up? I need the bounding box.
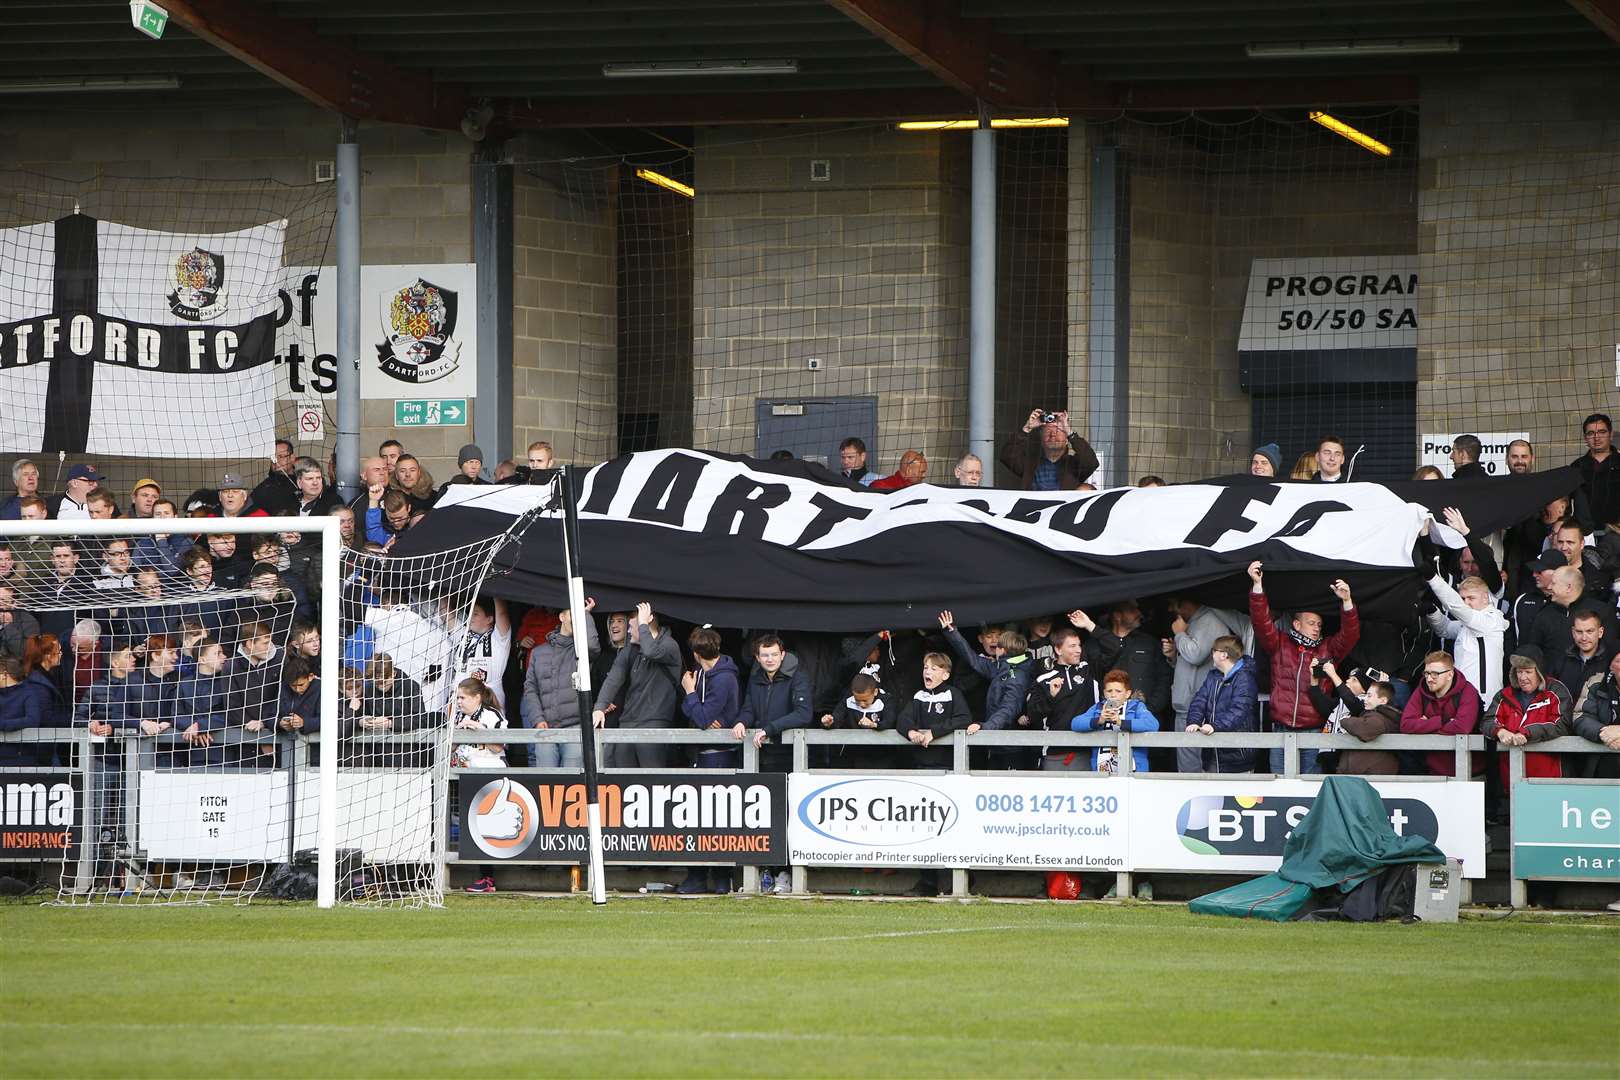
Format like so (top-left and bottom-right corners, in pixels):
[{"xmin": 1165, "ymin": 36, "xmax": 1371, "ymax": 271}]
[{"xmin": 512, "ymin": 167, "xmax": 619, "ymax": 465}]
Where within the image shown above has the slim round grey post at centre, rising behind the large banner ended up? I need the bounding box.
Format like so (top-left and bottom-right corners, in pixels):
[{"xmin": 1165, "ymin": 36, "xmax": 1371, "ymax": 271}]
[{"xmin": 965, "ymin": 108, "xmax": 996, "ymax": 472}]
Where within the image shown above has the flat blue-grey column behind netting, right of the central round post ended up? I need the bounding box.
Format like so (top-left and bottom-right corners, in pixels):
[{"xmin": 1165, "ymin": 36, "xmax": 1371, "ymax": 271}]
[{"xmin": 1087, "ymin": 146, "xmax": 1131, "ymax": 487}]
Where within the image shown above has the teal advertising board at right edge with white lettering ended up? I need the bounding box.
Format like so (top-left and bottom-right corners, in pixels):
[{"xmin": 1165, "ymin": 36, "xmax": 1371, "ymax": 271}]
[{"xmin": 1513, "ymin": 780, "xmax": 1620, "ymax": 881}]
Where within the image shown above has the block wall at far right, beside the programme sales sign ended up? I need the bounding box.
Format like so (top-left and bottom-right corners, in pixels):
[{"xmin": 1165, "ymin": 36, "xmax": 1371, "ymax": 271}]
[{"xmin": 1418, "ymin": 68, "xmax": 1620, "ymax": 468}]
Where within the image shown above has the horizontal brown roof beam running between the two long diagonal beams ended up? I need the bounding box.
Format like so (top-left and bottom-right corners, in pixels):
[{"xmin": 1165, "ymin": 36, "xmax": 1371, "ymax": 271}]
[{"xmin": 491, "ymin": 87, "xmax": 974, "ymax": 127}]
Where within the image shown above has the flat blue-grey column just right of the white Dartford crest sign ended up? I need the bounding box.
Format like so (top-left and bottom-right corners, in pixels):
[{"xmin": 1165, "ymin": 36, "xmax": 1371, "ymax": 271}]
[{"xmin": 473, "ymin": 160, "xmax": 522, "ymax": 470}]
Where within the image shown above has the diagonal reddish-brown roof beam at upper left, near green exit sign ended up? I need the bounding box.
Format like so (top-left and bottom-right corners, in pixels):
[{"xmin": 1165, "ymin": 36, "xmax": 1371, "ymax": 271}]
[{"xmin": 164, "ymin": 0, "xmax": 468, "ymax": 131}]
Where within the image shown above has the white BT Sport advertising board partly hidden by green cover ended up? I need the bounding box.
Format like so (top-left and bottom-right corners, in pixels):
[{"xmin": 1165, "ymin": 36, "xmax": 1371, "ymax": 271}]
[{"xmin": 1126, "ymin": 777, "xmax": 1486, "ymax": 878}]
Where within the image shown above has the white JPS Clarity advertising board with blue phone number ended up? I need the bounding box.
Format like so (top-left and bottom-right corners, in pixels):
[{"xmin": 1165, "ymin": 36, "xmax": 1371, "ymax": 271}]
[{"xmin": 787, "ymin": 774, "xmax": 1131, "ymax": 871}]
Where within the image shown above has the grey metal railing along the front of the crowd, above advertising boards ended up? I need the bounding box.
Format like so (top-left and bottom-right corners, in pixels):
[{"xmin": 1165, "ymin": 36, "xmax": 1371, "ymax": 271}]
[{"xmin": 0, "ymin": 729, "xmax": 1620, "ymax": 908}]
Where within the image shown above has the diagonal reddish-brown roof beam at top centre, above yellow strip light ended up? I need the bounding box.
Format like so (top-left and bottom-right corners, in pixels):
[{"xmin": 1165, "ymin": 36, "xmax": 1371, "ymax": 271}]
[{"xmin": 828, "ymin": 0, "xmax": 1074, "ymax": 108}]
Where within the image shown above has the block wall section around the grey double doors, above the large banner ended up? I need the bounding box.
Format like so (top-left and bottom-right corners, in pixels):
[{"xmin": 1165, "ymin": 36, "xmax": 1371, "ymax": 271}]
[{"xmin": 692, "ymin": 126, "xmax": 969, "ymax": 479}]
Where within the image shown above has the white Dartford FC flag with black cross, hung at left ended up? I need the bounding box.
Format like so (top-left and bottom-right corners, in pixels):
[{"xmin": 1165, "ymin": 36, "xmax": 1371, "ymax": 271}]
[{"xmin": 0, "ymin": 214, "xmax": 285, "ymax": 458}]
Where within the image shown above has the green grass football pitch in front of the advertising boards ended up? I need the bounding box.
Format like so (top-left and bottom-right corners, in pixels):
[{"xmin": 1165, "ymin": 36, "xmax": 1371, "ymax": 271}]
[{"xmin": 0, "ymin": 895, "xmax": 1620, "ymax": 1077}]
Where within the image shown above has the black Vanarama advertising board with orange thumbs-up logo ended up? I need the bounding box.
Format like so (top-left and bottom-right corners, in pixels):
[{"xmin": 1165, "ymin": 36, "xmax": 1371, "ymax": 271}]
[{"xmin": 457, "ymin": 772, "xmax": 787, "ymax": 865}]
